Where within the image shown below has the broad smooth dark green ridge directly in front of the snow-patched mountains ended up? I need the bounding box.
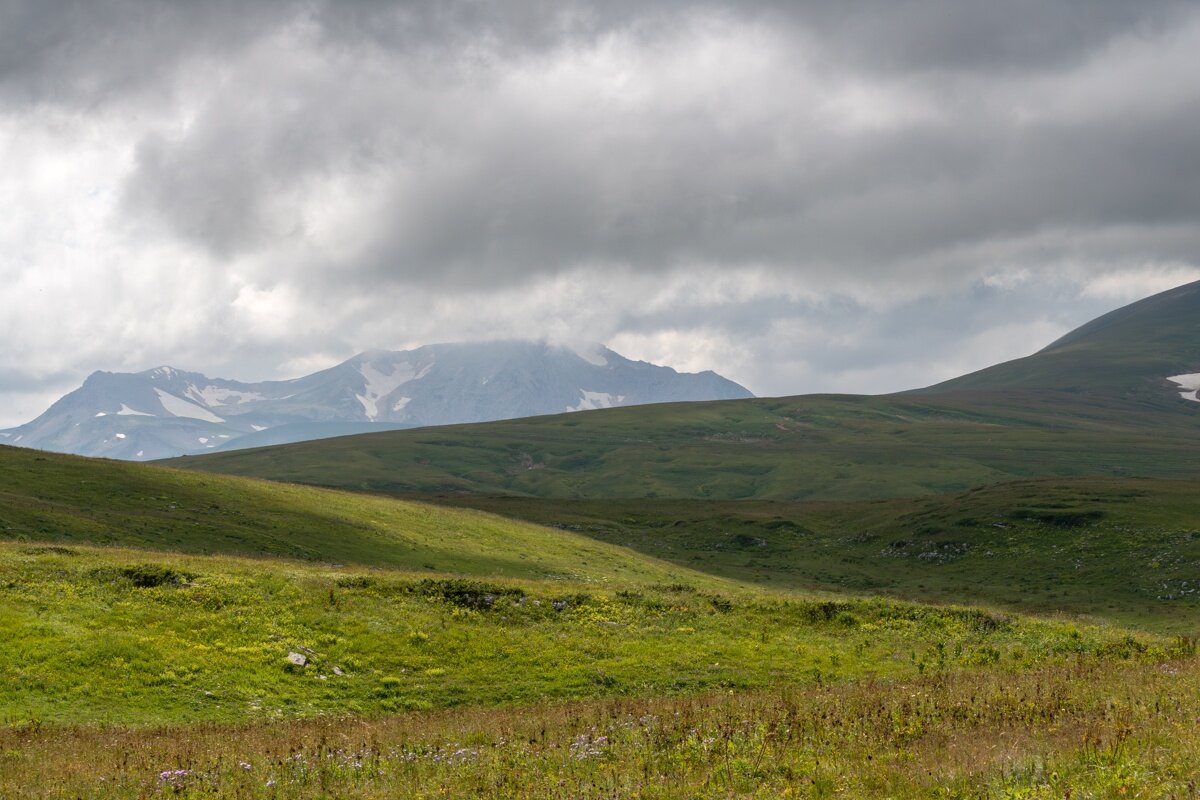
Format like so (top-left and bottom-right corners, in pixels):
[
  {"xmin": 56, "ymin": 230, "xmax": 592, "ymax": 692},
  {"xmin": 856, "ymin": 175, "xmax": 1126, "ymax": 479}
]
[{"xmin": 170, "ymin": 390, "xmax": 1200, "ymax": 500}]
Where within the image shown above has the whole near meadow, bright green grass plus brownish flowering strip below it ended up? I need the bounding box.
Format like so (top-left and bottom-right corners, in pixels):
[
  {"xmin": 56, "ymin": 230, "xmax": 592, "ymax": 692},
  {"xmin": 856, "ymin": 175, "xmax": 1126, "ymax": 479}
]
[{"xmin": 0, "ymin": 542, "xmax": 1200, "ymax": 799}]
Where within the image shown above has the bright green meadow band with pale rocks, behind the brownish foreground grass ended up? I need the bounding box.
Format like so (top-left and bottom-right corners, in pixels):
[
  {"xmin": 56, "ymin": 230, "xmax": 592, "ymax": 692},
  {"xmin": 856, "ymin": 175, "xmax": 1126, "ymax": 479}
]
[{"xmin": 0, "ymin": 543, "xmax": 1176, "ymax": 724}]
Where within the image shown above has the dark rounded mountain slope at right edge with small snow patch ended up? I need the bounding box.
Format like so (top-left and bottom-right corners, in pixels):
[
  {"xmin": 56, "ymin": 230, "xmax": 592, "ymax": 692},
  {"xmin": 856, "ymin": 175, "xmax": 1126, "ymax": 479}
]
[{"xmin": 913, "ymin": 281, "xmax": 1200, "ymax": 403}]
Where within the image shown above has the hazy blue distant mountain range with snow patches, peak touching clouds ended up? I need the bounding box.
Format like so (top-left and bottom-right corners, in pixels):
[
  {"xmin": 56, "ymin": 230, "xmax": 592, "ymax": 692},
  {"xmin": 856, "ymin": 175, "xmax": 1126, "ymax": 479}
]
[{"xmin": 0, "ymin": 342, "xmax": 752, "ymax": 461}]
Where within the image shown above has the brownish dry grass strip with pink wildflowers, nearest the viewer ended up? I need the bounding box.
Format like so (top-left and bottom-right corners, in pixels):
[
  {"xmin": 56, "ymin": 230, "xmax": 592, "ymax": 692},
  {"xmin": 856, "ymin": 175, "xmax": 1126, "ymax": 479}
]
[{"xmin": 0, "ymin": 656, "xmax": 1200, "ymax": 800}]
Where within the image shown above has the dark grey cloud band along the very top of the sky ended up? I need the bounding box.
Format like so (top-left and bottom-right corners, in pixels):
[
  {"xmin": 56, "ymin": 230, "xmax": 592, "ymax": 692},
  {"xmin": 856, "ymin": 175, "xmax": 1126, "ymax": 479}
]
[{"xmin": 0, "ymin": 0, "xmax": 1190, "ymax": 101}]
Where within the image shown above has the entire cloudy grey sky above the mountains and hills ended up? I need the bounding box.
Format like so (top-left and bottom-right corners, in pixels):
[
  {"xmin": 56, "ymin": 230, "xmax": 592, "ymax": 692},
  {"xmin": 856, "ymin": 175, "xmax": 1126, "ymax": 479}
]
[{"xmin": 0, "ymin": 0, "xmax": 1200, "ymax": 427}]
